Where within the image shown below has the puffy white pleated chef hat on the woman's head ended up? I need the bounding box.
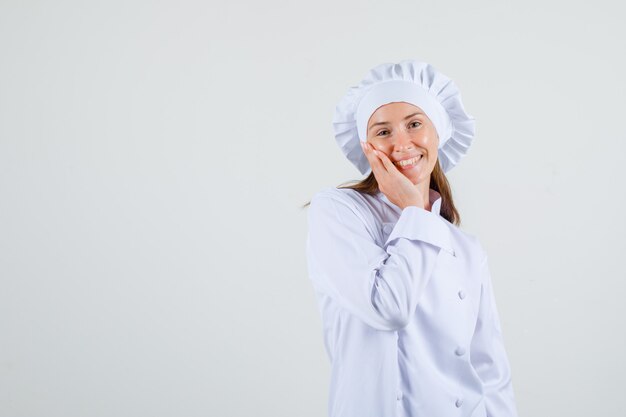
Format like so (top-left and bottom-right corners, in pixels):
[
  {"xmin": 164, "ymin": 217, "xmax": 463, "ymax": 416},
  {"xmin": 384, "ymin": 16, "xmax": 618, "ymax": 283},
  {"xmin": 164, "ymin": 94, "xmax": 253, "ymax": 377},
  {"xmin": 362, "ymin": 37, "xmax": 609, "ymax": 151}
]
[{"xmin": 333, "ymin": 59, "xmax": 475, "ymax": 175}]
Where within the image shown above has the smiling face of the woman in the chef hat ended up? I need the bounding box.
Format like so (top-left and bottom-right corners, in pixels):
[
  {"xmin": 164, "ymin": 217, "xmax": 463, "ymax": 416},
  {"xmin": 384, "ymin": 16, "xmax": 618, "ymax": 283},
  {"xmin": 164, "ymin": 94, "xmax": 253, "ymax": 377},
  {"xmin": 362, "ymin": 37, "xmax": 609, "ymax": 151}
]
[{"xmin": 367, "ymin": 102, "xmax": 439, "ymax": 186}]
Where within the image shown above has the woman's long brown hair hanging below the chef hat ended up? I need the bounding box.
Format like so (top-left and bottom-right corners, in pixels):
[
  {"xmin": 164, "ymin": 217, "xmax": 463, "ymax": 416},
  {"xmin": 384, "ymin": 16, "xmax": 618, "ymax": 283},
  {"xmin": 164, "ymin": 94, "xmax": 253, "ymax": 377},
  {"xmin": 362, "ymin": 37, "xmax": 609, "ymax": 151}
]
[{"xmin": 301, "ymin": 158, "xmax": 461, "ymax": 226}]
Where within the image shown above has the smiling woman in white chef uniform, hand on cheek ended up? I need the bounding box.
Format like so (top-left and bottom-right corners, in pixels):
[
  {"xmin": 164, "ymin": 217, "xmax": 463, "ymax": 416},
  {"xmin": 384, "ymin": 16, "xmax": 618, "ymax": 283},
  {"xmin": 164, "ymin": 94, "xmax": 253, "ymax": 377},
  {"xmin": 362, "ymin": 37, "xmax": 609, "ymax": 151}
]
[{"xmin": 307, "ymin": 60, "xmax": 517, "ymax": 417}]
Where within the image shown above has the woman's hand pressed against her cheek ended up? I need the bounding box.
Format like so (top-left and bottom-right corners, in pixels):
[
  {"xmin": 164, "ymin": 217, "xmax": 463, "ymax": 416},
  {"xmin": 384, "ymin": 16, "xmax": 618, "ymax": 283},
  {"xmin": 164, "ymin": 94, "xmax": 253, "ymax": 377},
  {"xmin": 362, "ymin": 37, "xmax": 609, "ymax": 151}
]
[{"xmin": 360, "ymin": 142, "xmax": 426, "ymax": 209}]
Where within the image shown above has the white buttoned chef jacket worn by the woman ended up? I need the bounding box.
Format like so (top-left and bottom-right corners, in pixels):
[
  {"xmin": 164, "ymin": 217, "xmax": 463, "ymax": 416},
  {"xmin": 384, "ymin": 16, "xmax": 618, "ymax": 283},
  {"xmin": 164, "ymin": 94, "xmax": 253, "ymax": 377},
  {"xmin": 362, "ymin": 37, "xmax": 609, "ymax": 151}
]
[{"xmin": 306, "ymin": 187, "xmax": 517, "ymax": 417}]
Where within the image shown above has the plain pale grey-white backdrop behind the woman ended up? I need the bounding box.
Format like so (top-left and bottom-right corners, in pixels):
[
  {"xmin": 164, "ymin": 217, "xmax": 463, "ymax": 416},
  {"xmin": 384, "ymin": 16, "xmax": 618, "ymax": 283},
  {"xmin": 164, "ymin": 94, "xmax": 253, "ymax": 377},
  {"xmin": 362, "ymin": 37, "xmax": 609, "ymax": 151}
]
[{"xmin": 0, "ymin": 0, "xmax": 626, "ymax": 417}]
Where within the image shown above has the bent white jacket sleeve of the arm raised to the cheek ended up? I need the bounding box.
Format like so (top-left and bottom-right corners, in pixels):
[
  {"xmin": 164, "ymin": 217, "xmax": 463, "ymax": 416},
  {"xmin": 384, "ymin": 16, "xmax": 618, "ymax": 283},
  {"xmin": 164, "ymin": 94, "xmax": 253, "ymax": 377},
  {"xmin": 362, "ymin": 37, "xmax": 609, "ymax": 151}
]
[{"xmin": 307, "ymin": 194, "xmax": 451, "ymax": 331}]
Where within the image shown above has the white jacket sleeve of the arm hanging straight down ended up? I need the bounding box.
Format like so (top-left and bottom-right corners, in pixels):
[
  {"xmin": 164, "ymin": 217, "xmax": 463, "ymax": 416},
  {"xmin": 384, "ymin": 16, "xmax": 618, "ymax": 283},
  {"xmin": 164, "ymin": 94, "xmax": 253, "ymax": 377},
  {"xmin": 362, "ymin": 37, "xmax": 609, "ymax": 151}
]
[{"xmin": 470, "ymin": 255, "xmax": 517, "ymax": 417}]
